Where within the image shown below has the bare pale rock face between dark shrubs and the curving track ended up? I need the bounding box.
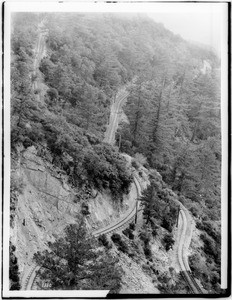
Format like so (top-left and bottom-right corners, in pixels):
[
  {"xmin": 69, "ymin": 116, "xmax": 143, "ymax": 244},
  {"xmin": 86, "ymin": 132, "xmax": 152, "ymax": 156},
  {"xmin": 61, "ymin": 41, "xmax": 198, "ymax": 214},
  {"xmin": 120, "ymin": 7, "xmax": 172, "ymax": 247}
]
[{"xmin": 11, "ymin": 147, "xmax": 136, "ymax": 280}]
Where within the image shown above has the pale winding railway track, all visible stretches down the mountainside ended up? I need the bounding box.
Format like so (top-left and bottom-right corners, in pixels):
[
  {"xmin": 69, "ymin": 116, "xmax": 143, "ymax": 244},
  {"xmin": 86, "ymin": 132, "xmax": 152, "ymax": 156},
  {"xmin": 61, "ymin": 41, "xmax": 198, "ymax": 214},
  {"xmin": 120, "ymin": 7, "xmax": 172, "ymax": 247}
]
[{"xmin": 23, "ymin": 28, "xmax": 203, "ymax": 294}]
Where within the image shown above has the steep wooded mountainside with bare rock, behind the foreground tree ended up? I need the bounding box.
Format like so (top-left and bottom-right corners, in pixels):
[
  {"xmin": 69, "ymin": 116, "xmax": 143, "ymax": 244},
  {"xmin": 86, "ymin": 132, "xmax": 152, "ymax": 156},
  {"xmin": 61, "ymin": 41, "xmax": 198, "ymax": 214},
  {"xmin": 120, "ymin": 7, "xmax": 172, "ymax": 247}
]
[{"xmin": 11, "ymin": 13, "xmax": 220, "ymax": 292}]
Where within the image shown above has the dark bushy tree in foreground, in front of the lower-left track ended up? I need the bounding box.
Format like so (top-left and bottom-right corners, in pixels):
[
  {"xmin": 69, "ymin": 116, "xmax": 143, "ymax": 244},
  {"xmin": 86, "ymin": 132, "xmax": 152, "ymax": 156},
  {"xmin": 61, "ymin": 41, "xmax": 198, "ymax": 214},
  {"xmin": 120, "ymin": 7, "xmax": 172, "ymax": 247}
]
[{"xmin": 34, "ymin": 219, "xmax": 122, "ymax": 293}]
